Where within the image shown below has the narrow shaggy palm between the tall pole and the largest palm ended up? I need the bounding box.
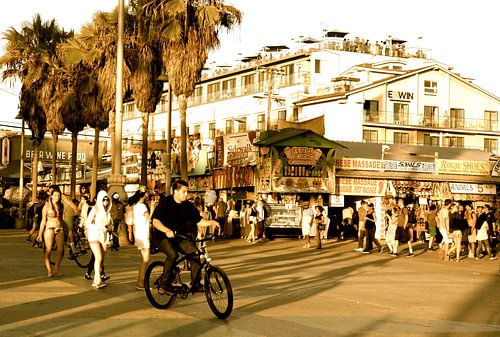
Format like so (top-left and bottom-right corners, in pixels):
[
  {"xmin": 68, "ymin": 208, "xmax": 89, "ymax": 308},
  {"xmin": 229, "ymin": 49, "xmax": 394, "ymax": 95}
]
[{"xmin": 126, "ymin": 0, "xmax": 163, "ymax": 186}]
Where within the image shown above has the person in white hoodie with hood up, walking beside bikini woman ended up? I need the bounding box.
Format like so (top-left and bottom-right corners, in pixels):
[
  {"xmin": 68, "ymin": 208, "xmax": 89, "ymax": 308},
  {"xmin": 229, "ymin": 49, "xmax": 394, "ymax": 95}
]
[{"xmin": 85, "ymin": 191, "xmax": 113, "ymax": 289}]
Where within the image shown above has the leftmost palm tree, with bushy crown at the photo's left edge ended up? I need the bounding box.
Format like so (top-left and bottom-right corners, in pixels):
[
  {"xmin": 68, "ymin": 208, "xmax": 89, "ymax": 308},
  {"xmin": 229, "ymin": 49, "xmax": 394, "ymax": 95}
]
[{"xmin": 0, "ymin": 14, "xmax": 71, "ymax": 201}]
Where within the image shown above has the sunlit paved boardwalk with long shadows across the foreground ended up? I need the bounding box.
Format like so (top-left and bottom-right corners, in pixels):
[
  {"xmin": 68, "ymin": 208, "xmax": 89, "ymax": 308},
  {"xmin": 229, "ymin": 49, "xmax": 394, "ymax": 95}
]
[{"xmin": 0, "ymin": 230, "xmax": 500, "ymax": 337}]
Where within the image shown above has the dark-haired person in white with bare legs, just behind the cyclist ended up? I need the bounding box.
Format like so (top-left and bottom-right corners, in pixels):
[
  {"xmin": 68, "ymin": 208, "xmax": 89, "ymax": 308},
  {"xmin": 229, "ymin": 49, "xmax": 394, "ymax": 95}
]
[{"xmin": 131, "ymin": 191, "xmax": 150, "ymax": 290}]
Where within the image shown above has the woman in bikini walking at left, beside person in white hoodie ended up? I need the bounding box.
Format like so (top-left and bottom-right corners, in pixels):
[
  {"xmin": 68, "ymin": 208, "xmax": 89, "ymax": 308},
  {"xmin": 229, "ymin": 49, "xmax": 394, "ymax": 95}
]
[{"xmin": 36, "ymin": 188, "xmax": 64, "ymax": 277}]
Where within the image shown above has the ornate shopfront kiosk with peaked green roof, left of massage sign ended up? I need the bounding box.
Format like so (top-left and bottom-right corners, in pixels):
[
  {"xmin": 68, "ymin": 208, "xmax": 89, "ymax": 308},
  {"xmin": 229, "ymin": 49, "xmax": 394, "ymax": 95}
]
[{"xmin": 255, "ymin": 129, "xmax": 343, "ymax": 235}]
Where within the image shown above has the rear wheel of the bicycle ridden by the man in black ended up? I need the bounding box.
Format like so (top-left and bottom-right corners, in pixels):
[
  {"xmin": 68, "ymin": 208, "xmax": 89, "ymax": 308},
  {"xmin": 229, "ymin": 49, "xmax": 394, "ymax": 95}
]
[{"xmin": 144, "ymin": 261, "xmax": 176, "ymax": 309}]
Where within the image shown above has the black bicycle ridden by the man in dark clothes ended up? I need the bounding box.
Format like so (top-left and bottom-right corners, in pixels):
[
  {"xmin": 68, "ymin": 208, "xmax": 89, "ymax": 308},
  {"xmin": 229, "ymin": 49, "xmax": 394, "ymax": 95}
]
[{"xmin": 144, "ymin": 235, "xmax": 233, "ymax": 319}]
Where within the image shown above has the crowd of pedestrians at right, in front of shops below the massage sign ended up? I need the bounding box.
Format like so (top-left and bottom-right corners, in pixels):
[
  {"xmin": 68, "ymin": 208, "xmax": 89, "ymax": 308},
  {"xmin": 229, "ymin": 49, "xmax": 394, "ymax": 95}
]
[{"xmin": 348, "ymin": 199, "xmax": 500, "ymax": 262}]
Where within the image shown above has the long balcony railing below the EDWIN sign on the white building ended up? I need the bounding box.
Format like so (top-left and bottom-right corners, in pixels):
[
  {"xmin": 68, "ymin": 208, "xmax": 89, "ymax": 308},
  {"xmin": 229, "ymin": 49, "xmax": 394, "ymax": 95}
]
[{"xmin": 363, "ymin": 111, "xmax": 500, "ymax": 132}]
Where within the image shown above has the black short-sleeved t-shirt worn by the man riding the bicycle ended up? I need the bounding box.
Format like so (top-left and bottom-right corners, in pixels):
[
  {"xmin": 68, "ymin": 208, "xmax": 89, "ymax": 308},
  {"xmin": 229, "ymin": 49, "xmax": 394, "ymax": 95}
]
[{"xmin": 152, "ymin": 195, "xmax": 201, "ymax": 240}]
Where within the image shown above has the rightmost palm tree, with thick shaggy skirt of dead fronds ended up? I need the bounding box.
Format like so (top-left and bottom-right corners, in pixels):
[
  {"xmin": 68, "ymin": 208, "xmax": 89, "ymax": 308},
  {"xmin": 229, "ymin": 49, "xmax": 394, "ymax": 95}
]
[{"xmin": 148, "ymin": 0, "xmax": 241, "ymax": 180}]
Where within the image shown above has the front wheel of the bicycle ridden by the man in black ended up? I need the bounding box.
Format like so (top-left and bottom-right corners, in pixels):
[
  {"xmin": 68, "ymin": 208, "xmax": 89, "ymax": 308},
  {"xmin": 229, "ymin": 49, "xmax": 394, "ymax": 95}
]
[{"xmin": 205, "ymin": 266, "xmax": 233, "ymax": 319}]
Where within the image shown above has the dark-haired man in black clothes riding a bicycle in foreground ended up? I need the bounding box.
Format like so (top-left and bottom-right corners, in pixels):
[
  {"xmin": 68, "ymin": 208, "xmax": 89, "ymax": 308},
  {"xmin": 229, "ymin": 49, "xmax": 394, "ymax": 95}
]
[{"xmin": 151, "ymin": 180, "xmax": 220, "ymax": 293}]
